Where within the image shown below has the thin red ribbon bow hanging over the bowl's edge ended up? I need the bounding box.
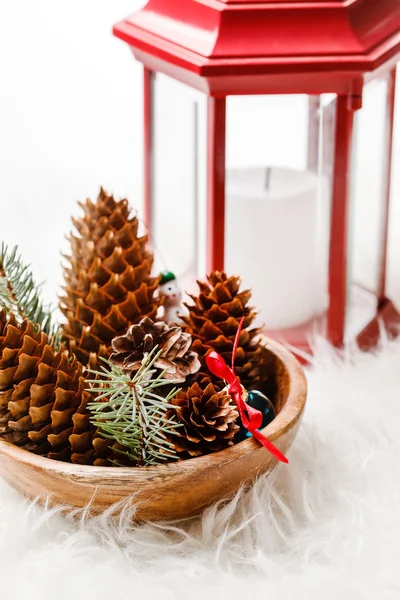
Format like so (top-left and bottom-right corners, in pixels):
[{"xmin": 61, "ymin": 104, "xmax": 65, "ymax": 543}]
[{"xmin": 206, "ymin": 317, "xmax": 289, "ymax": 463}]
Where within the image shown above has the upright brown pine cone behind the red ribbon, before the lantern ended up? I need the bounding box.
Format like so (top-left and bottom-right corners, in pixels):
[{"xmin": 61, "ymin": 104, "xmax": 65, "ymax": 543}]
[{"xmin": 183, "ymin": 271, "xmax": 265, "ymax": 389}]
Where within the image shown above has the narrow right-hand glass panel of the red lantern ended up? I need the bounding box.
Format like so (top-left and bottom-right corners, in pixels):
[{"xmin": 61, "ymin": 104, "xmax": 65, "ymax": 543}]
[{"xmin": 347, "ymin": 77, "xmax": 390, "ymax": 338}]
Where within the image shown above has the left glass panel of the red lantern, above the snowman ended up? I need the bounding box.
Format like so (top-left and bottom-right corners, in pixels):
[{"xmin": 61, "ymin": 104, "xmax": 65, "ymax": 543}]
[{"xmin": 150, "ymin": 73, "xmax": 207, "ymax": 290}]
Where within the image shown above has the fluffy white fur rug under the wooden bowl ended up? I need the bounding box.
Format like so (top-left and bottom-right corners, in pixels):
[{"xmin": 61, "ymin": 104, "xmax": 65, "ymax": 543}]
[{"xmin": 0, "ymin": 342, "xmax": 400, "ymax": 600}]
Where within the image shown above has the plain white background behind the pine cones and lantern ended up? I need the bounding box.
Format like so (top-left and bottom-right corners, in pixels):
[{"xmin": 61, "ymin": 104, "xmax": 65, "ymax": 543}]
[{"xmin": 0, "ymin": 0, "xmax": 400, "ymax": 316}]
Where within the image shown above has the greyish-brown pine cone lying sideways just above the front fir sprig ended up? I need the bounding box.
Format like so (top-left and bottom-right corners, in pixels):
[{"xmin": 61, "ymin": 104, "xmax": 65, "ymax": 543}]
[{"xmin": 110, "ymin": 317, "xmax": 200, "ymax": 381}]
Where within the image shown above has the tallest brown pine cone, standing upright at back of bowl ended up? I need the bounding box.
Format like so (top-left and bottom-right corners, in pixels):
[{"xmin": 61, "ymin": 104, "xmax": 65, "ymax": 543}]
[{"xmin": 60, "ymin": 189, "xmax": 158, "ymax": 365}]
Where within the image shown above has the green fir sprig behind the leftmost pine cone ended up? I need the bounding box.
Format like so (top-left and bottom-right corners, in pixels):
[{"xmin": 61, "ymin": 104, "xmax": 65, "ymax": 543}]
[{"xmin": 0, "ymin": 242, "xmax": 58, "ymax": 345}]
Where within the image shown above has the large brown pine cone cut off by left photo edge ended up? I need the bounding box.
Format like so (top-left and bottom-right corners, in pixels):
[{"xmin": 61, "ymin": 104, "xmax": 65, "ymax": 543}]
[{"xmin": 0, "ymin": 310, "xmax": 94, "ymax": 461}]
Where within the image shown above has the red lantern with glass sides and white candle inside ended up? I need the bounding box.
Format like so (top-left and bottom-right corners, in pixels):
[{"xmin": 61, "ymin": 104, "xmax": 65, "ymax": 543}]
[{"xmin": 114, "ymin": 0, "xmax": 400, "ymax": 356}]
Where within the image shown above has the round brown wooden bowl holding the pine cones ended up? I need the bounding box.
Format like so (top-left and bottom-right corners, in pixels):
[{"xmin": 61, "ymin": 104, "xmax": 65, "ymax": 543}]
[{"xmin": 0, "ymin": 338, "xmax": 307, "ymax": 521}]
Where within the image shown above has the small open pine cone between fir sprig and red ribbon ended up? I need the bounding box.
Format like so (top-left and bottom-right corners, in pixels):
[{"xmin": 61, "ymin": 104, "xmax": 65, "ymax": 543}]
[{"xmin": 166, "ymin": 383, "xmax": 239, "ymax": 458}]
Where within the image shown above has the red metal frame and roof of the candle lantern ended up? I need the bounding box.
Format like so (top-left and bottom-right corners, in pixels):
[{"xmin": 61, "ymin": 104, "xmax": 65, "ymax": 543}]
[{"xmin": 113, "ymin": 0, "xmax": 400, "ymax": 347}]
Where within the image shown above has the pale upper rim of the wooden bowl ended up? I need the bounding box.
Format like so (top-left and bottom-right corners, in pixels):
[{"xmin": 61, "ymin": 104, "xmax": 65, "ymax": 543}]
[{"xmin": 0, "ymin": 335, "xmax": 307, "ymax": 479}]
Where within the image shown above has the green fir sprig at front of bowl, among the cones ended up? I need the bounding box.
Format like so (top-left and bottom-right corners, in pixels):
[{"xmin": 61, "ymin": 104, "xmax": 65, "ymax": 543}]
[{"xmin": 87, "ymin": 346, "xmax": 181, "ymax": 466}]
